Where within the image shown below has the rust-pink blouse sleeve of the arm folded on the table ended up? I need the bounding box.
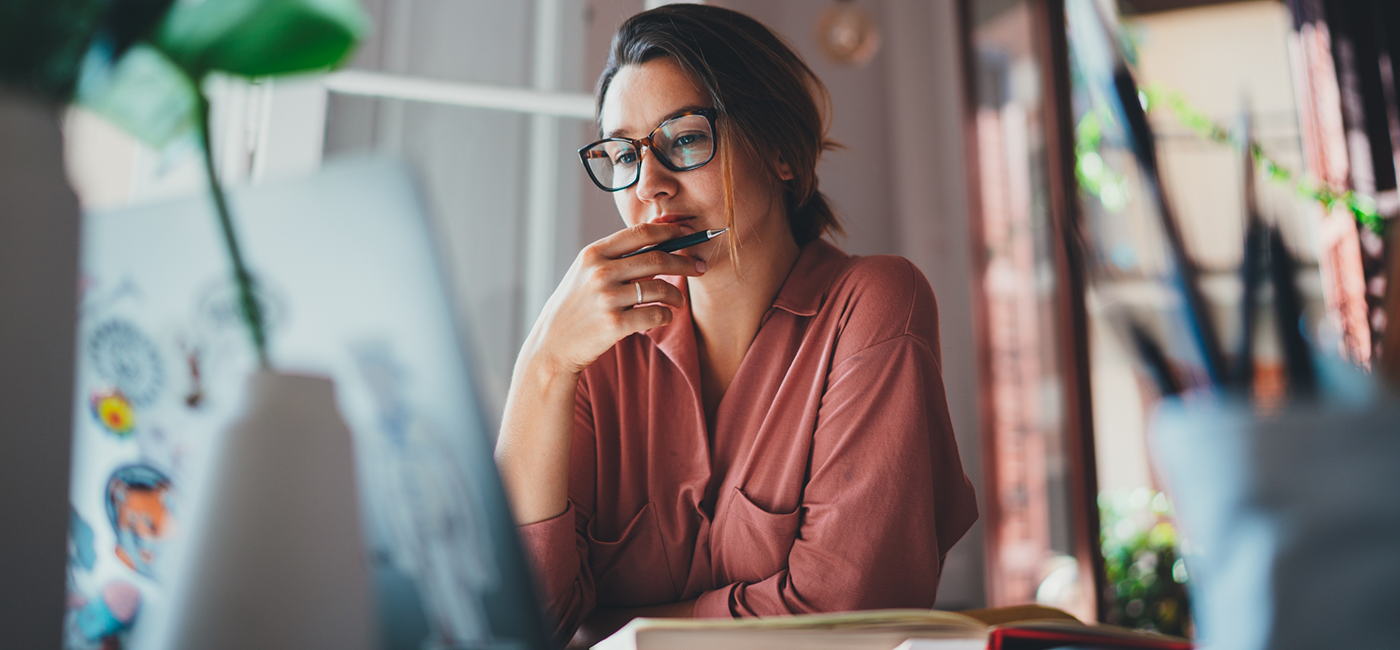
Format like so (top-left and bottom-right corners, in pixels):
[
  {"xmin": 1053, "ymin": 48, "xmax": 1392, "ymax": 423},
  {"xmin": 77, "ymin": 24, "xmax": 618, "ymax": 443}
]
[{"xmin": 696, "ymin": 262, "xmax": 977, "ymax": 616}]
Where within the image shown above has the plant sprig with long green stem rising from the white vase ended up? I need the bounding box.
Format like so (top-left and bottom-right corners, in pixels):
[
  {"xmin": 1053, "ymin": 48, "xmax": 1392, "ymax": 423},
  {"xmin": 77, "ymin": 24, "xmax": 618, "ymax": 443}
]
[{"xmin": 77, "ymin": 0, "xmax": 368, "ymax": 368}]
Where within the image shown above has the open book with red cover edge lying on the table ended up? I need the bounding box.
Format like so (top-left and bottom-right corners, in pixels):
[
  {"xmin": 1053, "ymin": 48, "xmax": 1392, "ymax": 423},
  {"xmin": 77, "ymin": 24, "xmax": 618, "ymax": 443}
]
[{"xmin": 594, "ymin": 607, "xmax": 1193, "ymax": 650}]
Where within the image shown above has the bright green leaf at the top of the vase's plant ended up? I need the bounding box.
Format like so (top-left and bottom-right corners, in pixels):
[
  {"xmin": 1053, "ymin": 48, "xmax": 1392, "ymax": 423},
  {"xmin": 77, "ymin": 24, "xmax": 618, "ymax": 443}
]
[{"xmin": 153, "ymin": 0, "xmax": 368, "ymax": 78}]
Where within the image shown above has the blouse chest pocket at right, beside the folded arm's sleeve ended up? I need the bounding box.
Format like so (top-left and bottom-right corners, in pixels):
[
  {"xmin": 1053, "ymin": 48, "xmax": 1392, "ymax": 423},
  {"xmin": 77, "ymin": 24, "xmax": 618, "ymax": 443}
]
[{"xmin": 713, "ymin": 488, "xmax": 802, "ymax": 584}]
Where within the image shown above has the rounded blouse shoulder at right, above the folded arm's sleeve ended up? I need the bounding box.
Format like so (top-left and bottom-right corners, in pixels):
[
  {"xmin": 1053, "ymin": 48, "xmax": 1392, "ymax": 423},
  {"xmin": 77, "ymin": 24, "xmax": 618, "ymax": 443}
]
[{"xmin": 822, "ymin": 255, "xmax": 938, "ymax": 354}]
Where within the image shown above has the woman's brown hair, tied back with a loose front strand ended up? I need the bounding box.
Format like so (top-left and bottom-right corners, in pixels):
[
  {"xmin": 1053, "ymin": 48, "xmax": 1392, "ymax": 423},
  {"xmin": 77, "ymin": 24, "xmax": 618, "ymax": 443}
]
[{"xmin": 598, "ymin": 4, "xmax": 844, "ymax": 253}]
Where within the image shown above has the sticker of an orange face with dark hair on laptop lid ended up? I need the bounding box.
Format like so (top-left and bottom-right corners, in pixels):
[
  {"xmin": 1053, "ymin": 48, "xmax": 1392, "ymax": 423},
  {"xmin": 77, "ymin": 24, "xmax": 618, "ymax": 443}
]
[{"xmin": 106, "ymin": 465, "xmax": 175, "ymax": 579}]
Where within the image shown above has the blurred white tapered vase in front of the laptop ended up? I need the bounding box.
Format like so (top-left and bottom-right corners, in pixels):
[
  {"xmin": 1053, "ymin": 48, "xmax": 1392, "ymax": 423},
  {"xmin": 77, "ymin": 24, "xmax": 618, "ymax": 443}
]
[{"xmin": 165, "ymin": 371, "xmax": 374, "ymax": 650}]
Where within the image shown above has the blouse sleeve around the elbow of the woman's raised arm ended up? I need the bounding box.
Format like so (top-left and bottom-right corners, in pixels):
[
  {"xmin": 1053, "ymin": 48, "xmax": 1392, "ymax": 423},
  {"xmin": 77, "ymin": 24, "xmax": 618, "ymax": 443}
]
[{"xmin": 518, "ymin": 367, "xmax": 596, "ymax": 647}]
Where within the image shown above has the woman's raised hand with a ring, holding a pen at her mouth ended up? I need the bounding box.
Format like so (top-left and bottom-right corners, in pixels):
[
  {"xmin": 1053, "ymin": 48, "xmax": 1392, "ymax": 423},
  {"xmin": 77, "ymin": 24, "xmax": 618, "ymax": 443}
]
[{"xmin": 521, "ymin": 224, "xmax": 706, "ymax": 374}]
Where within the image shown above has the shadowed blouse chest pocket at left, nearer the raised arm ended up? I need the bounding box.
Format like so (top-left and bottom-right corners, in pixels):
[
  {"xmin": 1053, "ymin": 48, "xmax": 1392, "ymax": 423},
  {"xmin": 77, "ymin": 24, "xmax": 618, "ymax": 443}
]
[{"xmin": 588, "ymin": 503, "xmax": 680, "ymax": 607}]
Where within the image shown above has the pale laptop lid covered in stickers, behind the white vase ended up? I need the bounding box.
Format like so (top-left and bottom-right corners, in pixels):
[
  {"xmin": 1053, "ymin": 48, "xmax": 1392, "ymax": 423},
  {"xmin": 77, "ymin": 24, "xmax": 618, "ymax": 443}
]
[{"xmin": 64, "ymin": 160, "xmax": 547, "ymax": 649}]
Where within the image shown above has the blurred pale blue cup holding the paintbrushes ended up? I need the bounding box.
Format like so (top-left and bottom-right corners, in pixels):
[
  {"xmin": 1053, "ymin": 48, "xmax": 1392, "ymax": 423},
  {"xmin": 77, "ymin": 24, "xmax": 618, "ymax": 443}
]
[{"xmin": 1151, "ymin": 359, "xmax": 1400, "ymax": 650}]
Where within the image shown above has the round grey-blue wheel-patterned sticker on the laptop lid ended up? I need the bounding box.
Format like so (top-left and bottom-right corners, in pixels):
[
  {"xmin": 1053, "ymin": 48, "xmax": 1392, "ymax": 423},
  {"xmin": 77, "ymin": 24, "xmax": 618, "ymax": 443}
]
[{"xmin": 87, "ymin": 319, "xmax": 165, "ymax": 406}]
